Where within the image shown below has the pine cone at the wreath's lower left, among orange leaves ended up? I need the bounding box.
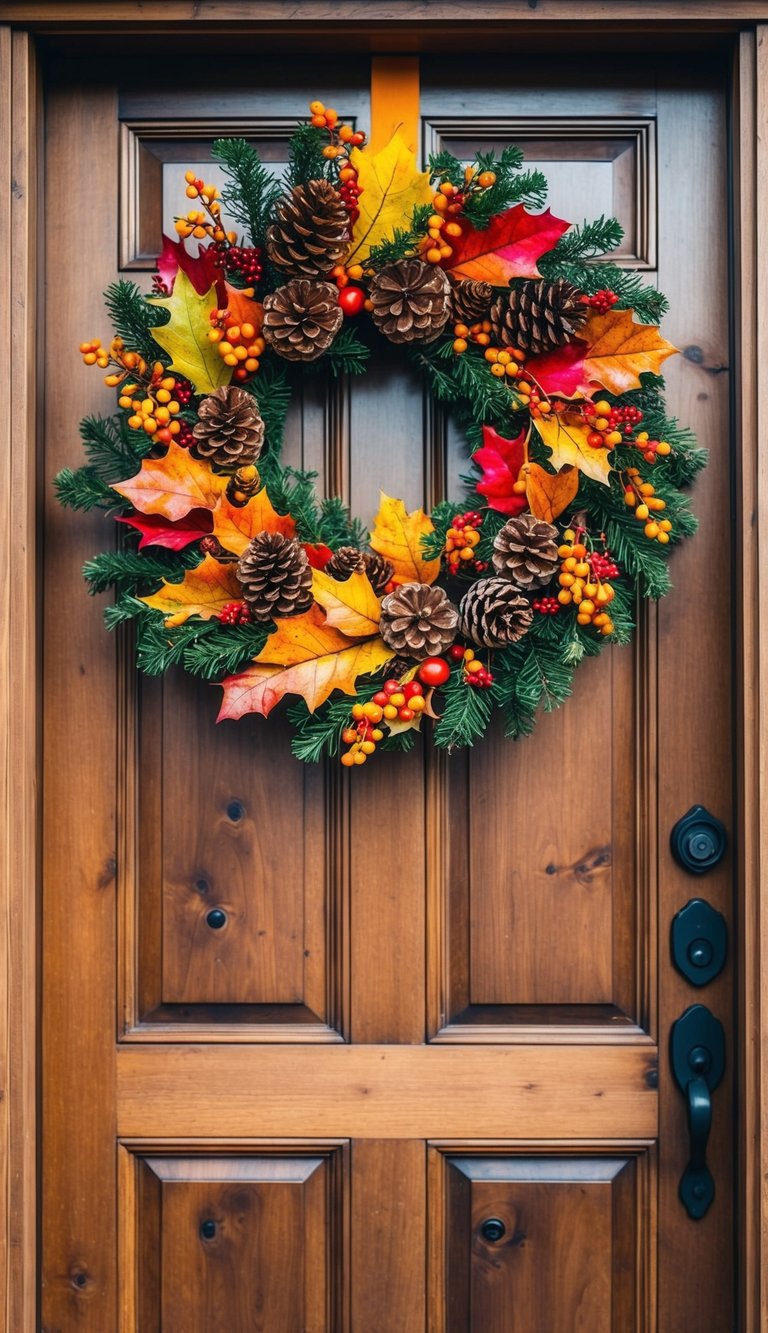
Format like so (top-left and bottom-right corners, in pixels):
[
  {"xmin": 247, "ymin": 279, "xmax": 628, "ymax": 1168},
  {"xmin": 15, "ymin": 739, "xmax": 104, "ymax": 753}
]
[{"xmin": 237, "ymin": 532, "xmax": 312, "ymax": 620}]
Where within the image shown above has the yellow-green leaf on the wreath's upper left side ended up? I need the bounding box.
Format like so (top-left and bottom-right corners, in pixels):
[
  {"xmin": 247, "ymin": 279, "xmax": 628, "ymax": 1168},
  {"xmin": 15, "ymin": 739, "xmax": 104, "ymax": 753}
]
[{"xmin": 151, "ymin": 269, "xmax": 232, "ymax": 393}]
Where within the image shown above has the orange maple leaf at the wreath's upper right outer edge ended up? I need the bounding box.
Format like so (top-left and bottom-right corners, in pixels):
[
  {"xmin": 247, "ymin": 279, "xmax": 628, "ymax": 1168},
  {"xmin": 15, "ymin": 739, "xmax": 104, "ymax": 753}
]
[{"xmin": 576, "ymin": 311, "xmax": 677, "ymax": 393}]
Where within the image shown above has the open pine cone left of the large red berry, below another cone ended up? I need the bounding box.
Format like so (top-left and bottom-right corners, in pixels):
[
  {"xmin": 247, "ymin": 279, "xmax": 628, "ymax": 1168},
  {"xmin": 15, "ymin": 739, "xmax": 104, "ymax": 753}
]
[{"xmin": 261, "ymin": 277, "xmax": 344, "ymax": 361}]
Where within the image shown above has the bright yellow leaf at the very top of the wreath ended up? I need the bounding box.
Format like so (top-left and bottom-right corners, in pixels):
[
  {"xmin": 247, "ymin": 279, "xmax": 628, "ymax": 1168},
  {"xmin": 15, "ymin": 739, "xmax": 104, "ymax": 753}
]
[{"xmin": 345, "ymin": 133, "xmax": 432, "ymax": 264}]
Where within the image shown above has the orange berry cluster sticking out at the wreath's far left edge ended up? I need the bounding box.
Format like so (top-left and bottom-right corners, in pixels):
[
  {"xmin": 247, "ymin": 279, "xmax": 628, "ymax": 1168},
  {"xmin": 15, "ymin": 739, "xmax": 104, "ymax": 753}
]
[{"xmin": 80, "ymin": 337, "xmax": 181, "ymax": 444}]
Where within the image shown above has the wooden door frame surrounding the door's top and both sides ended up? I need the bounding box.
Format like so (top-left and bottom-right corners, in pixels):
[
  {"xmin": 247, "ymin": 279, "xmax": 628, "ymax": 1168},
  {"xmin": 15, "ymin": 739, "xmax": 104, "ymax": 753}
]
[{"xmin": 0, "ymin": 0, "xmax": 768, "ymax": 1333}]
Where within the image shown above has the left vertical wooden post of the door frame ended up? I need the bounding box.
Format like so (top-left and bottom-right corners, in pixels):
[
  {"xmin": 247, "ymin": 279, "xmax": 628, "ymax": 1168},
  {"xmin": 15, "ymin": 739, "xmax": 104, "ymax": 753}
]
[{"xmin": 0, "ymin": 27, "xmax": 40, "ymax": 1333}]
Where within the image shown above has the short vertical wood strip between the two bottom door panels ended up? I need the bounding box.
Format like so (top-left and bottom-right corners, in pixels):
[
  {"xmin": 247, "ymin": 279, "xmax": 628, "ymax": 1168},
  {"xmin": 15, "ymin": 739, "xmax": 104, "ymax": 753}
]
[{"xmin": 351, "ymin": 1138, "xmax": 427, "ymax": 1333}]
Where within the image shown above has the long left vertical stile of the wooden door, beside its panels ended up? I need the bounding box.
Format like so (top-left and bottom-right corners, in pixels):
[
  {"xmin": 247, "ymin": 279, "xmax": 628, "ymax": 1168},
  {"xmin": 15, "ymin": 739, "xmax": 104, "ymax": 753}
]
[{"xmin": 41, "ymin": 85, "xmax": 117, "ymax": 1333}]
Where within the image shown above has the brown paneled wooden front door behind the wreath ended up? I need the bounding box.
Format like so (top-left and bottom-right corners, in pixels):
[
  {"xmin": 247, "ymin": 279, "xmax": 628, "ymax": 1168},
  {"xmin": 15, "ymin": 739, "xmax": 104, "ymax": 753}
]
[{"xmin": 40, "ymin": 37, "xmax": 735, "ymax": 1333}]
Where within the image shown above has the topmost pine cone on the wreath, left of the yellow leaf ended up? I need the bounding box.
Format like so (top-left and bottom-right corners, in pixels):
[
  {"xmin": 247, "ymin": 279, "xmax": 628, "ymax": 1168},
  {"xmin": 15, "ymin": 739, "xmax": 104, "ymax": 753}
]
[{"xmin": 267, "ymin": 180, "xmax": 349, "ymax": 277}]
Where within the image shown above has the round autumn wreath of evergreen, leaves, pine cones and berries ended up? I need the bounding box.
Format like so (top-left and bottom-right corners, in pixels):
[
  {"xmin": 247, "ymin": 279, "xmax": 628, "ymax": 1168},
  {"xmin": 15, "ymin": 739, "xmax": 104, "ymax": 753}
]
[{"xmin": 56, "ymin": 101, "xmax": 704, "ymax": 766}]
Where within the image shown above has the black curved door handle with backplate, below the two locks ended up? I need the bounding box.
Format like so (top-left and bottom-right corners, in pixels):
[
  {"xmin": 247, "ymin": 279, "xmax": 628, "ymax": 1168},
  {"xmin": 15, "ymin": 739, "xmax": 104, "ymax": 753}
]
[{"xmin": 671, "ymin": 1004, "xmax": 725, "ymax": 1221}]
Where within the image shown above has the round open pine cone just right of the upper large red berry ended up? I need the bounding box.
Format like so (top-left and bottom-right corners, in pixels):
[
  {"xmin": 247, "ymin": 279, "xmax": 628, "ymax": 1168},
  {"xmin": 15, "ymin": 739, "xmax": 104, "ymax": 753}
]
[{"xmin": 369, "ymin": 259, "xmax": 451, "ymax": 343}]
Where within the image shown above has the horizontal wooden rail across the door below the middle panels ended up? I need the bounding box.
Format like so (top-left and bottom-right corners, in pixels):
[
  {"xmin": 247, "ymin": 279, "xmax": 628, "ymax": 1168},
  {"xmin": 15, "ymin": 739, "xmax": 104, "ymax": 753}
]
[{"xmin": 117, "ymin": 1045, "xmax": 656, "ymax": 1138}]
